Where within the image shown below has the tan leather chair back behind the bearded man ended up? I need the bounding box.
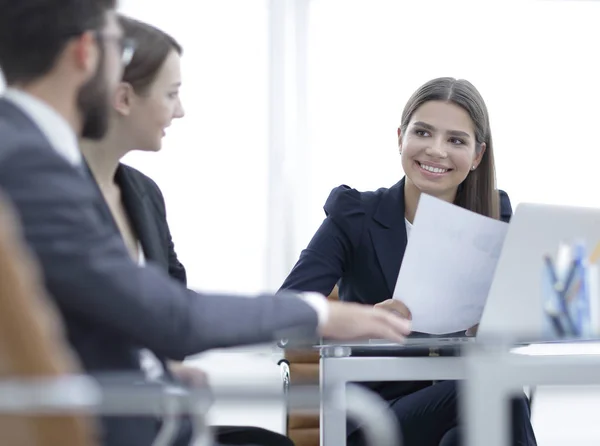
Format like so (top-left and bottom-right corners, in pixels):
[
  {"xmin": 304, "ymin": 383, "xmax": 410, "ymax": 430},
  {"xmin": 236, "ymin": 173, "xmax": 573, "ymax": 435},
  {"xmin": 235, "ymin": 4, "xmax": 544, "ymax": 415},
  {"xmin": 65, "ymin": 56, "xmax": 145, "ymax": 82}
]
[{"xmin": 0, "ymin": 196, "xmax": 97, "ymax": 446}]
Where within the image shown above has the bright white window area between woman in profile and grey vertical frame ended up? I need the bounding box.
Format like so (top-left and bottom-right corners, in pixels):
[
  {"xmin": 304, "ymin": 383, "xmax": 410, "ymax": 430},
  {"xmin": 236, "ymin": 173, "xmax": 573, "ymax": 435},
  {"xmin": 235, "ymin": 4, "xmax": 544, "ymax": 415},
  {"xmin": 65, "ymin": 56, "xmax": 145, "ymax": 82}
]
[{"xmin": 121, "ymin": 0, "xmax": 268, "ymax": 292}]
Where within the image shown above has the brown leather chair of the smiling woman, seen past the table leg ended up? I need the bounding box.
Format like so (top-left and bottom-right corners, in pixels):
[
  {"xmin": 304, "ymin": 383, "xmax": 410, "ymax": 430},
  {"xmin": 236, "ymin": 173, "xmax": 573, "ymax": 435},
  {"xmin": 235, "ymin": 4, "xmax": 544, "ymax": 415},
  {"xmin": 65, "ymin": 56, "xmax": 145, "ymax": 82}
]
[{"xmin": 285, "ymin": 286, "xmax": 339, "ymax": 446}]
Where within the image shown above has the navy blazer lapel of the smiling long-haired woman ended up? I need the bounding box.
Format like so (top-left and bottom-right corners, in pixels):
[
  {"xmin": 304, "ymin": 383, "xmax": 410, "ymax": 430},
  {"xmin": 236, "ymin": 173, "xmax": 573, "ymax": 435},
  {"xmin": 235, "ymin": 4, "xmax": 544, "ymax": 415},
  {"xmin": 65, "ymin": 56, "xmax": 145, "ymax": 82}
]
[{"xmin": 370, "ymin": 178, "xmax": 407, "ymax": 298}]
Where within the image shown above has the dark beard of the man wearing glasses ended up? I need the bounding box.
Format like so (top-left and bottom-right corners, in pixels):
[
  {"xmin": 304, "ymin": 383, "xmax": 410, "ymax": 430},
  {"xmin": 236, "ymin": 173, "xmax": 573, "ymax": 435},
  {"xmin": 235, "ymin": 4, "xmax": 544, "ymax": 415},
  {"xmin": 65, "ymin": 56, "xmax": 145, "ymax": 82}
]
[{"xmin": 77, "ymin": 57, "xmax": 110, "ymax": 140}]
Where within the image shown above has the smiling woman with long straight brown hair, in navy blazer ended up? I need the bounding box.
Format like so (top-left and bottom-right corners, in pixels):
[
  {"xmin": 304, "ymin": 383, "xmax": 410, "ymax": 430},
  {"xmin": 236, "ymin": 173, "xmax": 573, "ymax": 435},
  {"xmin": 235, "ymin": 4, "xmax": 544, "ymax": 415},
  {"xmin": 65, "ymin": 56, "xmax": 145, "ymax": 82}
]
[{"xmin": 282, "ymin": 77, "xmax": 536, "ymax": 446}]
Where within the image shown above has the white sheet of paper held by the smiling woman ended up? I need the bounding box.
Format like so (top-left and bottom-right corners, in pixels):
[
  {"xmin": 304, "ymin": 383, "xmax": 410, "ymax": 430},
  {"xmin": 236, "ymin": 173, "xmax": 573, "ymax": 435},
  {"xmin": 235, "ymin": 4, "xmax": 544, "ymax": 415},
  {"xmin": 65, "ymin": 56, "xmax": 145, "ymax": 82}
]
[{"xmin": 393, "ymin": 194, "xmax": 508, "ymax": 334}]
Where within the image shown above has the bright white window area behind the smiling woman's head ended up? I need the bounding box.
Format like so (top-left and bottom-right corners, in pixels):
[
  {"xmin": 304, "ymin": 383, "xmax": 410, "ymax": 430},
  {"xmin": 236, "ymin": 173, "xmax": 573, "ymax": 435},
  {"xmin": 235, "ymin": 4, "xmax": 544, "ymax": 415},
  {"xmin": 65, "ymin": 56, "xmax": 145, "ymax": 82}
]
[{"xmin": 296, "ymin": 0, "xmax": 600, "ymax": 254}]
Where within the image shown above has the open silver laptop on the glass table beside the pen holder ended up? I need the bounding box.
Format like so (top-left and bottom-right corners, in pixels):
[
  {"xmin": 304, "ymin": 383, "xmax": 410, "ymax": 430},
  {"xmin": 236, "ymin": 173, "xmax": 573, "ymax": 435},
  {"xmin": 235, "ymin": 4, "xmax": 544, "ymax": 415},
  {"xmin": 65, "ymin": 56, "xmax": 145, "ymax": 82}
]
[{"xmin": 324, "ymin": 203, "xmax": 600, "ymax": 348}]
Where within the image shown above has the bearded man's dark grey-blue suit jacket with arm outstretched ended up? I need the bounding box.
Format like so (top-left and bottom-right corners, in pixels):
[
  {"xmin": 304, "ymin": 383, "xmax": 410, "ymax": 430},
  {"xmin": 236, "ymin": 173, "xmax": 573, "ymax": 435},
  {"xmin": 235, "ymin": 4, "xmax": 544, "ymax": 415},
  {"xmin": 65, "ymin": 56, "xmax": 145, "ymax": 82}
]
[{"xmin": 0, "ymin": 99, "xmax": 318, "ymax": 446}]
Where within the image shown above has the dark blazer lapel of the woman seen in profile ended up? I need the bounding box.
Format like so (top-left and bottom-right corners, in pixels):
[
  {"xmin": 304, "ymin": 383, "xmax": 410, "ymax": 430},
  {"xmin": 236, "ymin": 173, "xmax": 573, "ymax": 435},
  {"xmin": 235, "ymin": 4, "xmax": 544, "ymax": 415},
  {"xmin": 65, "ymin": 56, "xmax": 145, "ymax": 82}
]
[{"xmin": 115, "ymin": 165, "xmax": 169, "ymax": 269}]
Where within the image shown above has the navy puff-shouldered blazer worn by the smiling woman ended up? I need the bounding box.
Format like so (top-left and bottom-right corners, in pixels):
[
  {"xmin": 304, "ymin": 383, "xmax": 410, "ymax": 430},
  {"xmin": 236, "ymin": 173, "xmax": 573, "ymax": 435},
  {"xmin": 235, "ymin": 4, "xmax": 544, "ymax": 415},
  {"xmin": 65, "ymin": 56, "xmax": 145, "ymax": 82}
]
[{"xmin": 281, "ymin": 179, "xmax": 512, "ymax": 399}]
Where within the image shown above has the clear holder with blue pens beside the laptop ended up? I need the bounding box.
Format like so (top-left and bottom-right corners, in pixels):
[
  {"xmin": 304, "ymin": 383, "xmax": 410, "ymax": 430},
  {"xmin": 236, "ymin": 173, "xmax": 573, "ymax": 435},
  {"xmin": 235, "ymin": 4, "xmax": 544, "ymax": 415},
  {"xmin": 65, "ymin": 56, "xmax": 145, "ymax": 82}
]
[{"xmin": 541, "ymin": 262, "xmax": 599, "ymax": 340}]
